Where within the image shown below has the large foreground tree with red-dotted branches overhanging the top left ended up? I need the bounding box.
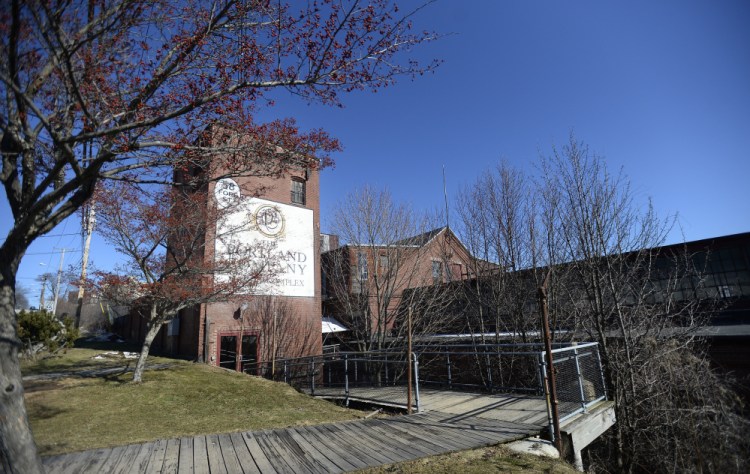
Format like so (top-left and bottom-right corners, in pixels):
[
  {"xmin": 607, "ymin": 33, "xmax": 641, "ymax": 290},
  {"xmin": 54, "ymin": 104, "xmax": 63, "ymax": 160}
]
[{"xmin": 0, "ymin": 0, "xmax": 435, "ymax": 473}]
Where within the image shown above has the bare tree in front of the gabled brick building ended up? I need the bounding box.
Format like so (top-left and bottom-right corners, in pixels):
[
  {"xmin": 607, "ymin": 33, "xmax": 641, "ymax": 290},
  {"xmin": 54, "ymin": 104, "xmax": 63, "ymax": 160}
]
[{"xmin": 323, "ymin": 187, "xmax": 466, "ymax": 351}]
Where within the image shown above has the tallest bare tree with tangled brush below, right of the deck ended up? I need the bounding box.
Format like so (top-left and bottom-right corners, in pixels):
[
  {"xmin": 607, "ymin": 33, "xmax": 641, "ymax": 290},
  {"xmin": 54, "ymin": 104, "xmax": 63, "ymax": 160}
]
[{"xmin": 542, "ymin": 137, "xmax": 747, "ymax": 472}]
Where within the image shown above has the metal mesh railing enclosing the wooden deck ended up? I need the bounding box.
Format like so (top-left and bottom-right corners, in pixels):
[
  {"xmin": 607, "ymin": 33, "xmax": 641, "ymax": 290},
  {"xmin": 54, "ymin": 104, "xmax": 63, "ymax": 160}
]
[{"xmin": 268, "ymin": 342, "xmax": 607, "ymax": 424}]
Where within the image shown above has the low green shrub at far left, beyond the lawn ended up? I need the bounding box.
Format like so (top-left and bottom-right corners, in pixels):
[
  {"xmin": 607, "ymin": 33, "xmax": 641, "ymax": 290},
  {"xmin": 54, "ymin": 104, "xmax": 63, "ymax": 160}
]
[{"xmin": 18, "ymin": 309, "xmax": 79, "ymax": 353}]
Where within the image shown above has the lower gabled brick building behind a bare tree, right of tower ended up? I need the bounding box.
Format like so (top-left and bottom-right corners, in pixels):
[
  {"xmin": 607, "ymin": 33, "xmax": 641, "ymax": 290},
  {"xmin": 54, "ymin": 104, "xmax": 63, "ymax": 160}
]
[{"xmin": 322, "ymin": 227, "xmax": 475, "ymax": 350}]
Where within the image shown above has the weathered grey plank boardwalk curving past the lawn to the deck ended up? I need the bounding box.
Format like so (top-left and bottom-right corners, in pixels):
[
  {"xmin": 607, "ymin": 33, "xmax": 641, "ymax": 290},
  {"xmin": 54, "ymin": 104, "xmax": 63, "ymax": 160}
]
[{"xmin": 43, "ymin": 391, "xmax": 547, "ymax": 474}]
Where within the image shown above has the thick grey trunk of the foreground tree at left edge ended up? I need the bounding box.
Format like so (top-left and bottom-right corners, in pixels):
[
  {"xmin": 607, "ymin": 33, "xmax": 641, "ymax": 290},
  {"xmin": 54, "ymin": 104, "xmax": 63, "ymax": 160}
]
[{"xmin": 0, "ymin": 272, "xmax": 44, "ymax": 473}]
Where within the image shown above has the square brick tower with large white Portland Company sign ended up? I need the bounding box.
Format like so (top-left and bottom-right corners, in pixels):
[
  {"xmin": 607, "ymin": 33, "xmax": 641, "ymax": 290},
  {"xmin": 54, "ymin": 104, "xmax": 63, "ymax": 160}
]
[{"xmin": 115, "ymin": 131, "xmax": 322, "ymax": 374}]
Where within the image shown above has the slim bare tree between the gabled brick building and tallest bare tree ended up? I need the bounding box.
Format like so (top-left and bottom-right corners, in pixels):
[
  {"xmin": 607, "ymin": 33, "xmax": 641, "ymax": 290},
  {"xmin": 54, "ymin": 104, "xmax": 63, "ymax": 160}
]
[{"xmin": 458, "ymin": 162, "xmax": 544, "ymax": 342}]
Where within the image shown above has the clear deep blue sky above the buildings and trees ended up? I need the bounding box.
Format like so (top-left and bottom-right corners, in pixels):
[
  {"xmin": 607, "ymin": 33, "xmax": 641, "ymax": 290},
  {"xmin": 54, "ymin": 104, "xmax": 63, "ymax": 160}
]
[{"xmin": 0, "ymin": 0, "xmax": 750, "ymax": 301}]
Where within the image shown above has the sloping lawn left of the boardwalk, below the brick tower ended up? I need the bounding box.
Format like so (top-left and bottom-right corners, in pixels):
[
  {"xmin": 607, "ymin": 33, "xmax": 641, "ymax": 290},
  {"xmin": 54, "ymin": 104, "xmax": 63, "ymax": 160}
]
[{"xmin": 22, "ymin": 349, "xmax": 363, "ymax": 455}]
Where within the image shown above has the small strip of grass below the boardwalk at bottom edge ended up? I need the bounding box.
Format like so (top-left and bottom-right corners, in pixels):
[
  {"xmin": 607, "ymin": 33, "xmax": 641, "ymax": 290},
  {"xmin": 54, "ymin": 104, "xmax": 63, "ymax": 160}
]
[{"xmin": 357, "ymin": 446, "xmax": 578, "ymax": 474}]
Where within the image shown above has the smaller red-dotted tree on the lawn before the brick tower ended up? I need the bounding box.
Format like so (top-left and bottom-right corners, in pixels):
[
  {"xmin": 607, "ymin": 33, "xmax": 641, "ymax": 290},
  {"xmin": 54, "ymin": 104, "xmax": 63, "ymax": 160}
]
[{"xmin": 92, "ymin": 183, "xmax": 278, "ymax": 383}]
